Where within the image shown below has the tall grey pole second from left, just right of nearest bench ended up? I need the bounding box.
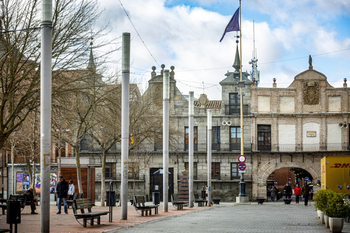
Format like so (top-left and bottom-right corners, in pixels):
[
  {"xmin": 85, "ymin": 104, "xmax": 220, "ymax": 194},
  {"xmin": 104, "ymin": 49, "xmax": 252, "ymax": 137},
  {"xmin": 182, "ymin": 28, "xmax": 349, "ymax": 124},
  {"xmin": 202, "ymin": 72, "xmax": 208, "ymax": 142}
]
[{"xmin": 120, "ymin": 32, "xmax": 130, "ymax": 220}]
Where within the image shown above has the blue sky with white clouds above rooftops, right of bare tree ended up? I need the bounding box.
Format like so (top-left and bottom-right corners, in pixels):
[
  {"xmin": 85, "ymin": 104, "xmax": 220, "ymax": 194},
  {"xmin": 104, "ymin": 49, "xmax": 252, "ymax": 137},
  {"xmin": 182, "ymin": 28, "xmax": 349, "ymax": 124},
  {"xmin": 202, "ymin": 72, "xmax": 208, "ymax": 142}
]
[{"xmin": 97, "ymin": 0, "xmax": 350, "ymax": 100}]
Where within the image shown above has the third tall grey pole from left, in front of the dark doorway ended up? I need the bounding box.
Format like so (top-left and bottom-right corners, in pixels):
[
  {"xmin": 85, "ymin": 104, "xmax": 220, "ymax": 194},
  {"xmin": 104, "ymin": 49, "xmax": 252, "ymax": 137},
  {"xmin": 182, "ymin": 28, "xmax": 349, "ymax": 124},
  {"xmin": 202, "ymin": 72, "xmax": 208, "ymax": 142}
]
[{"xmin": 163, "ymin": 70, "xmax": 169, "ymax": 212}]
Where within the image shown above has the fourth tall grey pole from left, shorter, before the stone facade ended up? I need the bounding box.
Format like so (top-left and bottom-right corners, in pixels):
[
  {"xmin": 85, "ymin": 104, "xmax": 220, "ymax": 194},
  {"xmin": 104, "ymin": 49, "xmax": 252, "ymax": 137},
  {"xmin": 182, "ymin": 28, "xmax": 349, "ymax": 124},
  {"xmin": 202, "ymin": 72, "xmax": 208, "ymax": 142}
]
[{"xmin": 188, "ymin": 91, "xmax": 194, "ymax": 207}]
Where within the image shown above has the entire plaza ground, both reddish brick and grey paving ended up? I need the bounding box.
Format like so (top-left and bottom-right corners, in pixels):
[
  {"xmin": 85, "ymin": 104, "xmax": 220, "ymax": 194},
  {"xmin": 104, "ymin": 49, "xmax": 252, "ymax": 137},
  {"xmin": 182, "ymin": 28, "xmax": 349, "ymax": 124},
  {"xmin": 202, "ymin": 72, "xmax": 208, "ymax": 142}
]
[{"xmin": 0, "ymin": 202, "xmax": 350, "ymax": 233}]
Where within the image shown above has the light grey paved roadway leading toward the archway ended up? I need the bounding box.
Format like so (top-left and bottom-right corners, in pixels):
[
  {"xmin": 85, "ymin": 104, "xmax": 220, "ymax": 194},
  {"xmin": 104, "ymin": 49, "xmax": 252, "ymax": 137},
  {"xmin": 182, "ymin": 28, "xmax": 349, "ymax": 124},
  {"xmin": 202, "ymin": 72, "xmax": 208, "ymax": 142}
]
[{"xmin": 110, "ymin": 202, "xmax": 350, "ymax": 233}]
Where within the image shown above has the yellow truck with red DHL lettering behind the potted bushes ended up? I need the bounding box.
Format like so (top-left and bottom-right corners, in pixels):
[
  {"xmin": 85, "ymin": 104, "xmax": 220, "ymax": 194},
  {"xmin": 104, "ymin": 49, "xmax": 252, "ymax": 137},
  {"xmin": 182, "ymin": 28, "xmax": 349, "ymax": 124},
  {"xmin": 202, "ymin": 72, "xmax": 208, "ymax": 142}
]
[{"xmin": 321, "ymin": 156, "xmax": 350, "ymax": 194}]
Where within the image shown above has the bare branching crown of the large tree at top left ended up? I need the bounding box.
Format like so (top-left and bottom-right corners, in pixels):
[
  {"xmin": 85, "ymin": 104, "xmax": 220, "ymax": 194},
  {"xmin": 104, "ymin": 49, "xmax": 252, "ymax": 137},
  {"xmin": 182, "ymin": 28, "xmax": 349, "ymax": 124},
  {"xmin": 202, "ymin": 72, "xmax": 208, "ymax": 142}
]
[{"xmin": 0, "ymin": 0, "xmax": 117, "ymax": 149}]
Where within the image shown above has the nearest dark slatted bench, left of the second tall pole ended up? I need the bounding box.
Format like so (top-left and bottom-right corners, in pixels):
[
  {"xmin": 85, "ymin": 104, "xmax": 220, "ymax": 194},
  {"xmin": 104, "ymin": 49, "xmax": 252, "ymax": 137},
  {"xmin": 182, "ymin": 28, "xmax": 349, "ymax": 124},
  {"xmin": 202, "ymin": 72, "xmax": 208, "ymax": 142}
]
[{"xmin": 72, "ymin": 199, "xmax": 109, "ymax": 227}]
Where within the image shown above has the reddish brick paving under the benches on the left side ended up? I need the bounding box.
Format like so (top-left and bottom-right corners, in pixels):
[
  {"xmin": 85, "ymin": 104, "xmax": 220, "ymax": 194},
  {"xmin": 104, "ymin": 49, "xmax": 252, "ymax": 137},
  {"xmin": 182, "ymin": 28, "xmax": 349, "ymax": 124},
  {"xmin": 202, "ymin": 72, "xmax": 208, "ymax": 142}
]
[{"xmin": 0, "ymin": 203, "xmax": 209, "ymax": 233}]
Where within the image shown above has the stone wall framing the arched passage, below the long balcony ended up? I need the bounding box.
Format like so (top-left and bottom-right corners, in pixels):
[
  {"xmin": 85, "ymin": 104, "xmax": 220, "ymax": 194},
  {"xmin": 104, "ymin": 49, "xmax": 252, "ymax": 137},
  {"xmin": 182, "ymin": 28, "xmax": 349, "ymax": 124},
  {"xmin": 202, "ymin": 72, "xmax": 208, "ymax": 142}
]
[{"xmin": 252, "ymin": 154, "xmax": 322, "ymax": 199}]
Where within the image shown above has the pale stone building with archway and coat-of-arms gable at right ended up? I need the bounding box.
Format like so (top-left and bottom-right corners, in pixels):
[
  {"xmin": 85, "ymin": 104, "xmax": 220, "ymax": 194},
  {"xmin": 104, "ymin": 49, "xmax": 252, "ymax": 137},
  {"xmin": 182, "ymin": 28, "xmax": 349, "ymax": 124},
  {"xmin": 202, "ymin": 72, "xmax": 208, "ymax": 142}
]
[{"xmin": 251, "ymin": 62, "xmax": 350, "ymax": 198}]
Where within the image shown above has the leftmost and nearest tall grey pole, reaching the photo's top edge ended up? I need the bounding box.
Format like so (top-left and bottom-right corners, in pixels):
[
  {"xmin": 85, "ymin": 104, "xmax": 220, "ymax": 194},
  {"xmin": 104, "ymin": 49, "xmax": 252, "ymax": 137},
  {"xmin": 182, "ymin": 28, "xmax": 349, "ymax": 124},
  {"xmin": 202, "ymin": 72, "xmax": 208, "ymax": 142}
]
[{"xmin": 40, "ymin": 0, "xmax": 52, "ymax": 233}]
